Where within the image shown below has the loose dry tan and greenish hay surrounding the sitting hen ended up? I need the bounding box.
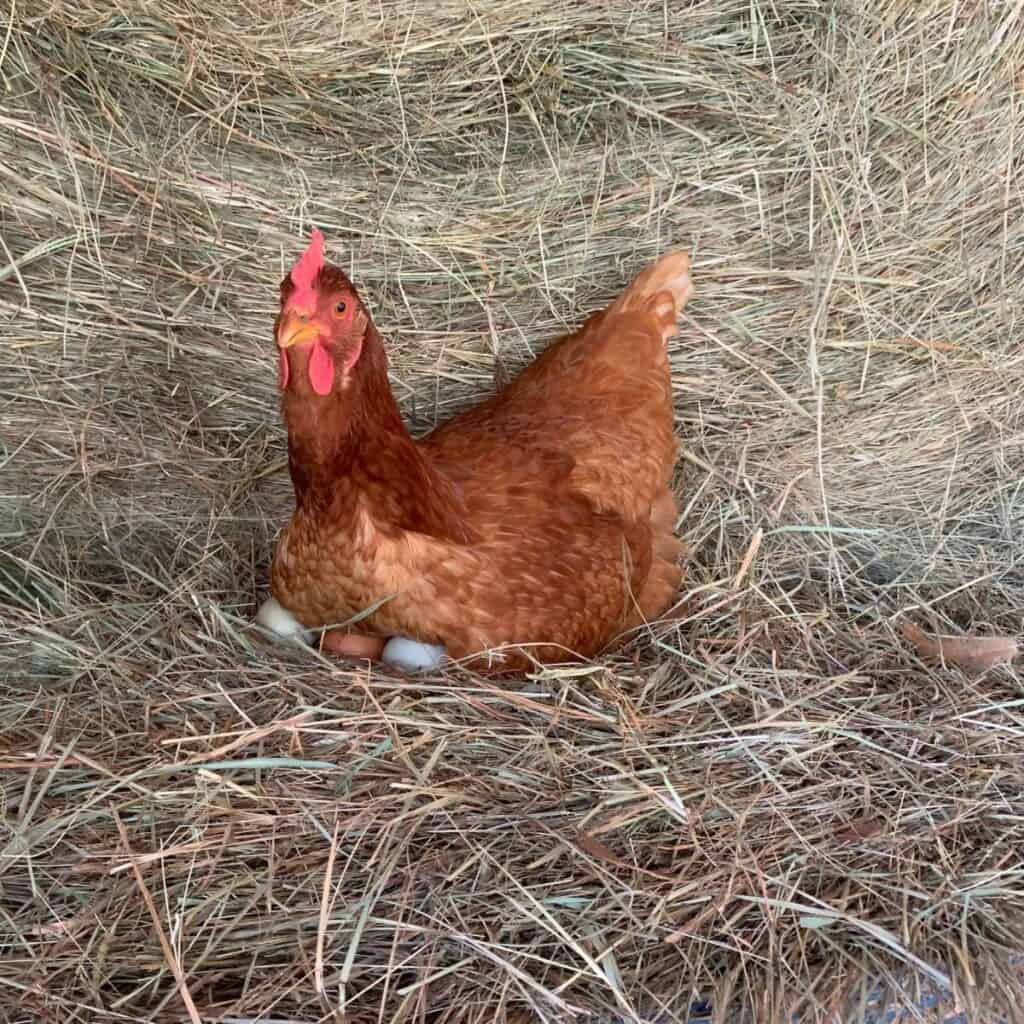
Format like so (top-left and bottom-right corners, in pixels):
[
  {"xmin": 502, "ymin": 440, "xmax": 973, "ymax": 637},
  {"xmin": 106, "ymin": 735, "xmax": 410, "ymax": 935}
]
[{"xmin": 0, "ymin": 0, "xmax": 1024, "ymax": 1024}]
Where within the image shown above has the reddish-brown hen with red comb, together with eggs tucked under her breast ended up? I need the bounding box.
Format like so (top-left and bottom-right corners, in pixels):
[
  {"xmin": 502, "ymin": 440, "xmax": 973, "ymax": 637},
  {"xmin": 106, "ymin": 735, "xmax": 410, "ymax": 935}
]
[{"xmin": 257, "ymin": 230, "xmax": 691, "ymax": 672}]
